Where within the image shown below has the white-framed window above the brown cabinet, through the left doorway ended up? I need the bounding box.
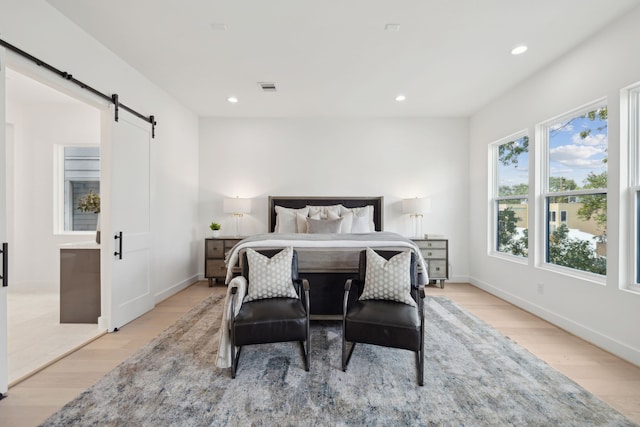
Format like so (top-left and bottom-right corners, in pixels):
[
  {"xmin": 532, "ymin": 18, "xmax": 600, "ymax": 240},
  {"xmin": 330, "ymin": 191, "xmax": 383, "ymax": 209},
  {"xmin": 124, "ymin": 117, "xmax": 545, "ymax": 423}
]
[{"xmin": 56, "ymin": 146, "xmax": 100, "ymax": 232}]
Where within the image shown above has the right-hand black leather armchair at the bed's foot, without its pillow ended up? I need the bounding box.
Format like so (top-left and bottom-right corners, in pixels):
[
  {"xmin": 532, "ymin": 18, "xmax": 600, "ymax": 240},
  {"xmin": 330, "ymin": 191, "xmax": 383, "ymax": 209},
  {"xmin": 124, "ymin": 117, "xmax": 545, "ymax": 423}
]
[{"xmin": 342, "ymin": 250, "xmax": 425, "ymax": 386}]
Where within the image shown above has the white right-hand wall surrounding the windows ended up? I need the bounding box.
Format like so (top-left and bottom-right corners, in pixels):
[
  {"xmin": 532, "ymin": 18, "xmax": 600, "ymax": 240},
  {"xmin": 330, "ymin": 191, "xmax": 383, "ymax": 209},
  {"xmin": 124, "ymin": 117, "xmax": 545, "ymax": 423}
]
[{"xmin": 469, "ymin": 9, "xmax": 640, "ymax": 365}]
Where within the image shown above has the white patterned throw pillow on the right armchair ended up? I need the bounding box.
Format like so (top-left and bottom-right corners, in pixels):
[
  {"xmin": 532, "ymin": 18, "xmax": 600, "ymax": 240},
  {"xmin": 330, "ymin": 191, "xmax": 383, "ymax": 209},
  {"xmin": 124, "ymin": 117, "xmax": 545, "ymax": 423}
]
[{"xmin": 360, "ymin": 248, "xmax": 416, "ymax": 307}]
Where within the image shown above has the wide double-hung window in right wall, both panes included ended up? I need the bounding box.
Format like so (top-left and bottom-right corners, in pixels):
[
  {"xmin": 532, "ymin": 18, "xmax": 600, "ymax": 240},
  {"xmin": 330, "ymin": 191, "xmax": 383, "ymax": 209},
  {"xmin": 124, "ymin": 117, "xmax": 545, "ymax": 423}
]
[{"xmin": 541, "ymin": 103, "xmax": 608, "ymax": 275}]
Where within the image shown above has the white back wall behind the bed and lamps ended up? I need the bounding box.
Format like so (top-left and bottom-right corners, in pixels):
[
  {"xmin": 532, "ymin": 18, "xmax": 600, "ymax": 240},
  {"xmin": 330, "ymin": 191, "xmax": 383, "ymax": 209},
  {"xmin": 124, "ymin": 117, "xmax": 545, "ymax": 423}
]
[{"xmin": 199, "ymin": 118, "xmax": 469, "ymax": 281}]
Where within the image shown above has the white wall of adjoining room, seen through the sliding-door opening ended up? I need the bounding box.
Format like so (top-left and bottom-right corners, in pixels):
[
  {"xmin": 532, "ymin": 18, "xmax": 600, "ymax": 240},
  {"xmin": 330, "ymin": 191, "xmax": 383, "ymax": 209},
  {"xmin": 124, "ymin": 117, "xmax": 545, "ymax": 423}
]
[{"xmin": 7, "ymin": 100, "xmax": 100, "ymax": 291}]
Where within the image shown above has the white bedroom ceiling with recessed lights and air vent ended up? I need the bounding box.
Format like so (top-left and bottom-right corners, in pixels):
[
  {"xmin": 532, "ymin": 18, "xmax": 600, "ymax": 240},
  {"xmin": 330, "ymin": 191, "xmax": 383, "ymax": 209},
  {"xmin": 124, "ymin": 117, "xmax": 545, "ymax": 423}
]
[{"xmin": 40, "ymin": 0, "xmax": 640, "ymax": 117}]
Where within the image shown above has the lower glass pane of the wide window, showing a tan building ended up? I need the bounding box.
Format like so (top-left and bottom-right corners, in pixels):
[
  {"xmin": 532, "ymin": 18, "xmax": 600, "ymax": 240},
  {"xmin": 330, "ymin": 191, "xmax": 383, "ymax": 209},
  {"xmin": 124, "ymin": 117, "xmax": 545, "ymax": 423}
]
[{"xmin": 547, "ymin": 193, "xmax": 607, "ymax": 275}]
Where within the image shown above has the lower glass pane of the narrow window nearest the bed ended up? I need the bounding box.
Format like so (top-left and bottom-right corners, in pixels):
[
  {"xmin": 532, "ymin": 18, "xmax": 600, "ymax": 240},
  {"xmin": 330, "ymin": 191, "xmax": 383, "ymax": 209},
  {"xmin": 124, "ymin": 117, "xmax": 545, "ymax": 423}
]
[{"xmin": 496, "ymin": 199, "xmax": 529, "ymax": 257}]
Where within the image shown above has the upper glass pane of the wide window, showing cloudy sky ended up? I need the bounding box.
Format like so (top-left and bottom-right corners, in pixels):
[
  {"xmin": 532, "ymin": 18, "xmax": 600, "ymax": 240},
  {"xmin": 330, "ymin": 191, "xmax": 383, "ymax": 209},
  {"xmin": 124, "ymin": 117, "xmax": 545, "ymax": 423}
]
[{"xmin": 548, "ymin": 106, "xmax": 608, "ymax": 192}]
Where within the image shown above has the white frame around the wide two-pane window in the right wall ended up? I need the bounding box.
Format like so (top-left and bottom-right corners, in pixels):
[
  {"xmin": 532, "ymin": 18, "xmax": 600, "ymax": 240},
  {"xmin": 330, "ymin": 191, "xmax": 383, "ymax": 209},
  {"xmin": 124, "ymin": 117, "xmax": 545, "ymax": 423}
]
[{"xmin": 535, "ymin": 98, "xmax": 611, "ymax": 286}]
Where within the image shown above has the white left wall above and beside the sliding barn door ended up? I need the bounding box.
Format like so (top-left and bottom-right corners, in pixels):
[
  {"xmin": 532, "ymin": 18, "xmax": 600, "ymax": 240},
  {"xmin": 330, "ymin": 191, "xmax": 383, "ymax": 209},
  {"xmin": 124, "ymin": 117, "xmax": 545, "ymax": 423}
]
[{"xmin": 0, "ymin": 0, "xmax": 201, "ymax": 300}]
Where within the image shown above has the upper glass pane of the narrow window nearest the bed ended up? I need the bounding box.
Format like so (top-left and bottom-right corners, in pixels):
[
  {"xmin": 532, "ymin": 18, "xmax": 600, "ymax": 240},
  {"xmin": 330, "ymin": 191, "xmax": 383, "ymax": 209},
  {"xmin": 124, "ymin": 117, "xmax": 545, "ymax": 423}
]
[{"xmin": 497, "ymin": 136, "xmax": 529, "ymax": 197}]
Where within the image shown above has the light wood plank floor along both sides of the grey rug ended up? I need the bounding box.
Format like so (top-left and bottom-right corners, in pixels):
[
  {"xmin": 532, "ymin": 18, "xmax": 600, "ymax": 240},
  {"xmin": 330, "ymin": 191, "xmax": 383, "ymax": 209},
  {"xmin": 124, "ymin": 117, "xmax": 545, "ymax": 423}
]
[{"xmin": 0, "ymin": 282, "xmax": 640, "ymax": 427}]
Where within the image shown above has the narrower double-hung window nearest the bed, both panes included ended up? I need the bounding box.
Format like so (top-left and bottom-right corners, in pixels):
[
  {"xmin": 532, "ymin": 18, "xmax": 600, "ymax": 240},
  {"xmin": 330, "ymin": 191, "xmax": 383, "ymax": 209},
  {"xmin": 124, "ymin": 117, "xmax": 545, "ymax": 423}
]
[{"xmin": 493, "ymin": 134, "xmax": 529, "ymax": 257}]
